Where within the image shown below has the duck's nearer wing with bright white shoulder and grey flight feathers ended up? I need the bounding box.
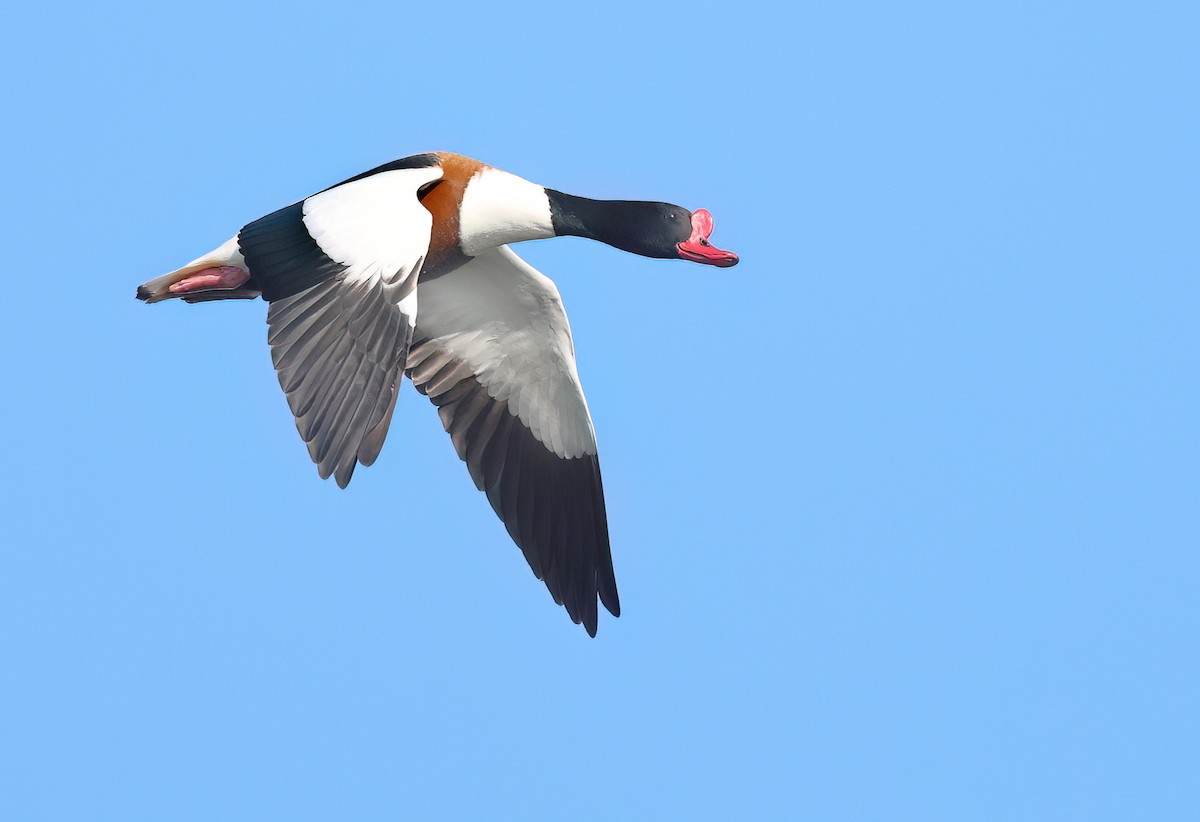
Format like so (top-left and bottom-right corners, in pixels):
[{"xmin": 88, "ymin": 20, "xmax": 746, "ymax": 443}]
[{"xmin": 238, "ymin": 157, "xmax": 442, "ymax": 488}]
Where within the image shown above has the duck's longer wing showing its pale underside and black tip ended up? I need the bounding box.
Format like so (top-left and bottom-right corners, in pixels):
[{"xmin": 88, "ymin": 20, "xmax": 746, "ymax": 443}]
[{"xmin": 408, "ymin": 246, "xmax": 620, "ymax": 636}]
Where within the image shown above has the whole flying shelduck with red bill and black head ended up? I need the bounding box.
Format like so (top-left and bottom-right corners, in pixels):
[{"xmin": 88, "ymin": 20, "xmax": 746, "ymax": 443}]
[{"xmin": 137, "ymin": 152, "xmax": 738, "ymax": 636}]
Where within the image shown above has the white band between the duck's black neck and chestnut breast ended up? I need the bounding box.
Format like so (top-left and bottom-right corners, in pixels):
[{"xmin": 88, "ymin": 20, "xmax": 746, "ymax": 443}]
[{"xmin": 458, "ymin": 168, "xmax": 554, "ymax": 257}]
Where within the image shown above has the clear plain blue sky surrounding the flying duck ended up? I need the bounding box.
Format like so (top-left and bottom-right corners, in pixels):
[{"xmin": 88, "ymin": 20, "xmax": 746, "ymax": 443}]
[{"xmin": 0, "ymin": 2, "xmax": 1200, "ymax": 821}]
